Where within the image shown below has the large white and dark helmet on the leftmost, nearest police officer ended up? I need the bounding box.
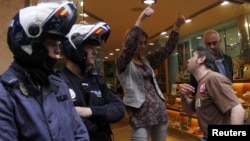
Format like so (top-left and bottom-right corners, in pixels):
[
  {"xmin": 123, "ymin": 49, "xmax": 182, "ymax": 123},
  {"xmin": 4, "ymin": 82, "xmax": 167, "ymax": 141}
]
[{"xmin": 7, "ymin": 1, "xmax": 77, "ymax": 65}]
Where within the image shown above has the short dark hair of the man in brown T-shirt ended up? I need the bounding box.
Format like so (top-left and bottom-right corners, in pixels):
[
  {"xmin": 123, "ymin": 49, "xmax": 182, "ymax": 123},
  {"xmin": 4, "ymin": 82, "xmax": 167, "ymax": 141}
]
[{"xmin": 193, "ymin": 47, "xmax": 215, "ymax": 70}]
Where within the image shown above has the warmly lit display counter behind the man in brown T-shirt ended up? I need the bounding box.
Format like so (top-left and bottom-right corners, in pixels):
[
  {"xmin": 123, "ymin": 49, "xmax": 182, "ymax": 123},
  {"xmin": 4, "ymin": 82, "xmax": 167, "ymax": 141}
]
[{"xmin": 166, "ymin": 81, "xmax": 250, "ymax": 140}]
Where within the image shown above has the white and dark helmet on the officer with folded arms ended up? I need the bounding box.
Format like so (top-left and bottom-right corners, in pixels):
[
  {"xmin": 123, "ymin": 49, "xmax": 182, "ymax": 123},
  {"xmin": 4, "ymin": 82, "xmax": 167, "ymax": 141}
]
[{"xmin": 61, "ymin": 22, "xmax": 111, "ymax": 69}]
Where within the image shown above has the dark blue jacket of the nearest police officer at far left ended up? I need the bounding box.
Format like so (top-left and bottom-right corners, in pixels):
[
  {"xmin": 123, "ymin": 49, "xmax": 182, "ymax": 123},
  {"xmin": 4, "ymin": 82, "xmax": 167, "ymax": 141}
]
[{"xmin": 0, "ymin": 62, "xmax": 89, "ymax": 141}]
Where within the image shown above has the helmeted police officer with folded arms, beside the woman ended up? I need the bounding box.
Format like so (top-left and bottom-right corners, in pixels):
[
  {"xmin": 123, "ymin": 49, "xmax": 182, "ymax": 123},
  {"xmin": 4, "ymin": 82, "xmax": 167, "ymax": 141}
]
[{"xmin": 59, "ymin": 22, "xmax": 125, "ymax": 141}]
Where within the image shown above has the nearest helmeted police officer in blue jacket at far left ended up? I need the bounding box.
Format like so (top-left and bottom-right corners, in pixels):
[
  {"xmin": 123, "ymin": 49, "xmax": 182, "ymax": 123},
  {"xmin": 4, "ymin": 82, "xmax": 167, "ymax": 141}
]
[{"xmin": 0, "ymin": 2, "xmax": 89, "ymax": 141}]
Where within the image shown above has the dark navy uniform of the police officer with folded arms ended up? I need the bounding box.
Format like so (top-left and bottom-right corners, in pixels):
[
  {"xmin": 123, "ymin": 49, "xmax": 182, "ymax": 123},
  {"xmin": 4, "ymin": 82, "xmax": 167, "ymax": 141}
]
[{"xmin": 58, "ymin": 67, "xmax": 125, "ymax": 141}]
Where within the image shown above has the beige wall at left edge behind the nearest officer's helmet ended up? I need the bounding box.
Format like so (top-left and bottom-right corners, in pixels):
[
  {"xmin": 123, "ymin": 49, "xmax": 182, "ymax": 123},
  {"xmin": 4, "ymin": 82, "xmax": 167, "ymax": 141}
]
[{"xmin": 0, "ymin": 0, "xmax": 25, "ymax": 74}]
